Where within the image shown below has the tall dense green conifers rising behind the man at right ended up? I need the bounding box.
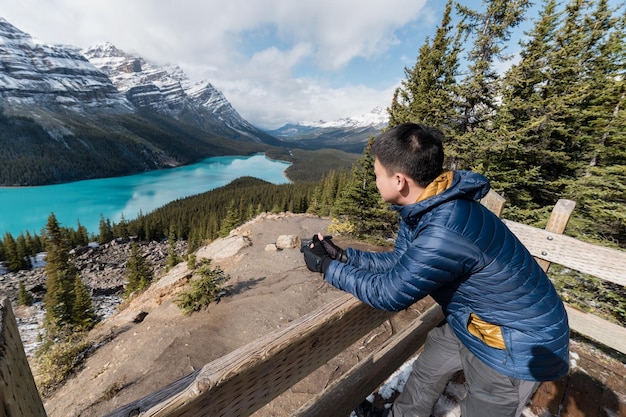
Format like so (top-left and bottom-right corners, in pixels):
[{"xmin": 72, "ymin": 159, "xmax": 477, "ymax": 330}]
[{"xmin": 389, "ymin": 0, "xmax": 626, "ymax": 248}]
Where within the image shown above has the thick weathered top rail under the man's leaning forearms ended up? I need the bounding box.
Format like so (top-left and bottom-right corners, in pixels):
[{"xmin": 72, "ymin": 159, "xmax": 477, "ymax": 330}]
[{"xmin": 108, "ymin": 295, "xmax": 394, "ymax": 417}]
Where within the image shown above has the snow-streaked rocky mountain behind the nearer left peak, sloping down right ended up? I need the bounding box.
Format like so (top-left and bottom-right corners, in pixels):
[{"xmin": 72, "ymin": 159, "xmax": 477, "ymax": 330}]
[{"xmin": 82, "ymin": 43, "xmax": 280, "ymax": 144}]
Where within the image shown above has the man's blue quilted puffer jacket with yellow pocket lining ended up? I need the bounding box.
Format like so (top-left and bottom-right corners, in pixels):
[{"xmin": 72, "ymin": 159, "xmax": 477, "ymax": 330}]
[{"xmin": 325, "ymin": 171, "xmax": 569, "ymax": 381}]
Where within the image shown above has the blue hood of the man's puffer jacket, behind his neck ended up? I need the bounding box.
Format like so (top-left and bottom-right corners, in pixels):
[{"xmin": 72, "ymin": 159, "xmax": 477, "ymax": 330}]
[{"xmin": 391, "ymin": 171, "xmax": 491, "ymax": 223}]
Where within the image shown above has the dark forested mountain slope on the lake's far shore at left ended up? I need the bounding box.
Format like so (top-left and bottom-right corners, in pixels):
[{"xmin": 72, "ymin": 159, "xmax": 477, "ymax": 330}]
[{"xmin": 0, "ymin": 111, "xmax": 270, "ymax": 186}]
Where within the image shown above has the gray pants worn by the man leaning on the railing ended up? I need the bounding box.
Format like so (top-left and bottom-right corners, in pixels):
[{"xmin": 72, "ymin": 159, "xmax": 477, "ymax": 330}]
[{"xmin": 389, "ymin": 324, "xmax": 539, "ymax": 417}]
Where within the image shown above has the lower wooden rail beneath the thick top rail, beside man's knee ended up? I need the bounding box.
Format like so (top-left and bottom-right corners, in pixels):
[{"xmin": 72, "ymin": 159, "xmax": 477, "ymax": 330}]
[{"xmin": 294, "ymin": 304, "xmax": 444, "ymax": 417}]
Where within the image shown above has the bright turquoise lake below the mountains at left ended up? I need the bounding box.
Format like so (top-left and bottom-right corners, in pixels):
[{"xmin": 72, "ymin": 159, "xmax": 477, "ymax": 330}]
[{"xmin": 0, "ymin": 154, "xmax": 290, "ymax": 239}]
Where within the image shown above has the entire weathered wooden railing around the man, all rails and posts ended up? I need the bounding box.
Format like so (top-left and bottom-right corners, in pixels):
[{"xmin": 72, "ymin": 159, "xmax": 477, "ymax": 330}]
[{"xmin": 0, "ymin": 192, "xmax": 626, "ymax": 417}]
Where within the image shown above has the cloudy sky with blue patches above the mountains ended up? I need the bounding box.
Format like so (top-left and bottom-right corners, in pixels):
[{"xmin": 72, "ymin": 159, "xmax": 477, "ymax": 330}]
[{"xmin": 0, "ymin": 0, "xmax": 532, "ymax": 129}]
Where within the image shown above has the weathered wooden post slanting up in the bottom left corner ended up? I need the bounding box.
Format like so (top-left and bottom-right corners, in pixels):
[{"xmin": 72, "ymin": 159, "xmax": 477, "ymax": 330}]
[{"xmin": 0, "ymin": 298, "xmax": 46, "ymax": 417}]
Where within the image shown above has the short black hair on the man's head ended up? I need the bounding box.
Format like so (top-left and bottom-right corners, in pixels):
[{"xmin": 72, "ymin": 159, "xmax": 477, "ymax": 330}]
[{"xmin": 371, "ymin": 123, "xmax": 444, "ymax": 187}]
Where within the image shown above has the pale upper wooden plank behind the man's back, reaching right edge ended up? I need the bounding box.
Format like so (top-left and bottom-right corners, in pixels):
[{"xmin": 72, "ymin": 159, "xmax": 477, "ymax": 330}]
[{"xmin": 504, "ymin": 220, "xmax": 626, "ymax": 286}]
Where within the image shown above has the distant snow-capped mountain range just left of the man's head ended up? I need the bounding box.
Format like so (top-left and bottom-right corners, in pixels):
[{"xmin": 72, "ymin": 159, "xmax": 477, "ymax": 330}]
[{"xmin": 268, "ymin": 107, "xmax": 389, "ymax": 153}]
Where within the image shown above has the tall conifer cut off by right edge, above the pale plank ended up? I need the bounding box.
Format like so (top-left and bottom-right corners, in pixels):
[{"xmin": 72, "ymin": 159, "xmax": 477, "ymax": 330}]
[{"xmin": 563, "ymin": 0, "xmax": 626, "ymax": 247}]
